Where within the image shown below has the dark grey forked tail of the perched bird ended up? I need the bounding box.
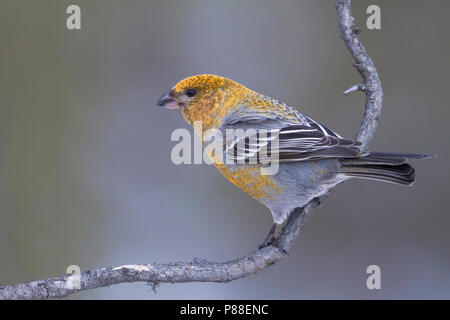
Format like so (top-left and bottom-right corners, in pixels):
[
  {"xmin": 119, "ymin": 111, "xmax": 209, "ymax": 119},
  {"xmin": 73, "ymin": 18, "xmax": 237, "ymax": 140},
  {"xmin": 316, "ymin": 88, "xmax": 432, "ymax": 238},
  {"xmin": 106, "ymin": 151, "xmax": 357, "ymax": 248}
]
[{"xmin": 340, "ymin": 152, "xmax": 435, "ymax": 186}]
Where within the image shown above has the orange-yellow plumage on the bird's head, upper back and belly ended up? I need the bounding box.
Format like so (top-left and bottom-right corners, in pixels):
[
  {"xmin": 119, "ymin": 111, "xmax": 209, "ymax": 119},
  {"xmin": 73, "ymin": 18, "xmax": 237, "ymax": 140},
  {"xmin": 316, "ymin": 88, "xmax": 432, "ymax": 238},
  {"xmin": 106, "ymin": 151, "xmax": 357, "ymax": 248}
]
[{"xmin": 172, "ymin": 74, "xmax": 286, "ymax": 200}]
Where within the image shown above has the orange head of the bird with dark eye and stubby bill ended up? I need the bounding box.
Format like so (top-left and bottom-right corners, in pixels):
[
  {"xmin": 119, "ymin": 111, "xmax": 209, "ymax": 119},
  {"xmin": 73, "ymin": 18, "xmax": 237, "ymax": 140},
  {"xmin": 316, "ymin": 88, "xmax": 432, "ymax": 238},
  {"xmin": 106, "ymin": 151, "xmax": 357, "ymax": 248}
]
[{"xmin": 157, "ymin": 74, "xmax": 251, "ymax": 130}]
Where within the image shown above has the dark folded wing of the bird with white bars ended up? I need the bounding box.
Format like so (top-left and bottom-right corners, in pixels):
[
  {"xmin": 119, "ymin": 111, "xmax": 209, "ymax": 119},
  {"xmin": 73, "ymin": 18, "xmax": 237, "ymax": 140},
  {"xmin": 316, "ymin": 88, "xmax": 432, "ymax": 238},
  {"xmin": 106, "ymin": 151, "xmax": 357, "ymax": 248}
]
[{"xmin": 224, "ymin": 117, "xmax": 361, "ymax": 163}]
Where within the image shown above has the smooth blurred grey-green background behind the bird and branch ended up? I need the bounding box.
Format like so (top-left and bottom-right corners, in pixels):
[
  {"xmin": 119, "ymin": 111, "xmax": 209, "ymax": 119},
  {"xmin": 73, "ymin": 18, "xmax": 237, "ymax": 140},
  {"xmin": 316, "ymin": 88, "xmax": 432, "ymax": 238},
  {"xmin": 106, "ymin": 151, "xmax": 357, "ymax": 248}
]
[{"xmin": 0, "ymin": 0, "xmax": 450, "ymax": 299}]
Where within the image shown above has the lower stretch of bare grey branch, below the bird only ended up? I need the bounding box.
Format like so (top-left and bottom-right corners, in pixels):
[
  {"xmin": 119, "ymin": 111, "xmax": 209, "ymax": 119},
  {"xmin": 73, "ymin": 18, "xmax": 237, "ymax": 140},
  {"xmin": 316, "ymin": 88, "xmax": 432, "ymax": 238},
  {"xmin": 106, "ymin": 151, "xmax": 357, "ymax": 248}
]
[{"xmin": 0, "ymin": 202, "xmax": 315, "ymax": 299}]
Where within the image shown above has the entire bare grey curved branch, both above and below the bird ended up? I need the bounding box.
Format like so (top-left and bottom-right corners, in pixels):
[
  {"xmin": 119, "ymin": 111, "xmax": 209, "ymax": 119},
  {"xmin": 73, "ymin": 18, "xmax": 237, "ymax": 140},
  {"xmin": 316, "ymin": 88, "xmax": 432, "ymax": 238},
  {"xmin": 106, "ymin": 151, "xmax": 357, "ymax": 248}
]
[{"xmin": 0, "ymin": 0, "xmax": 383, "ymax": 299}]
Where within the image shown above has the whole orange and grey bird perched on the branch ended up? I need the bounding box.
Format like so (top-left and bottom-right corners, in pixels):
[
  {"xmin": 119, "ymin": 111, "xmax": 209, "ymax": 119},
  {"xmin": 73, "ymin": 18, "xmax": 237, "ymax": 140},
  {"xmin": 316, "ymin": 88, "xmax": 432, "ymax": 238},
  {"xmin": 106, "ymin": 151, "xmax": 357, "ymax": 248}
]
[{"xmin": 157, "ymin": 74, "xmax": 434, "ymax": 247}]
